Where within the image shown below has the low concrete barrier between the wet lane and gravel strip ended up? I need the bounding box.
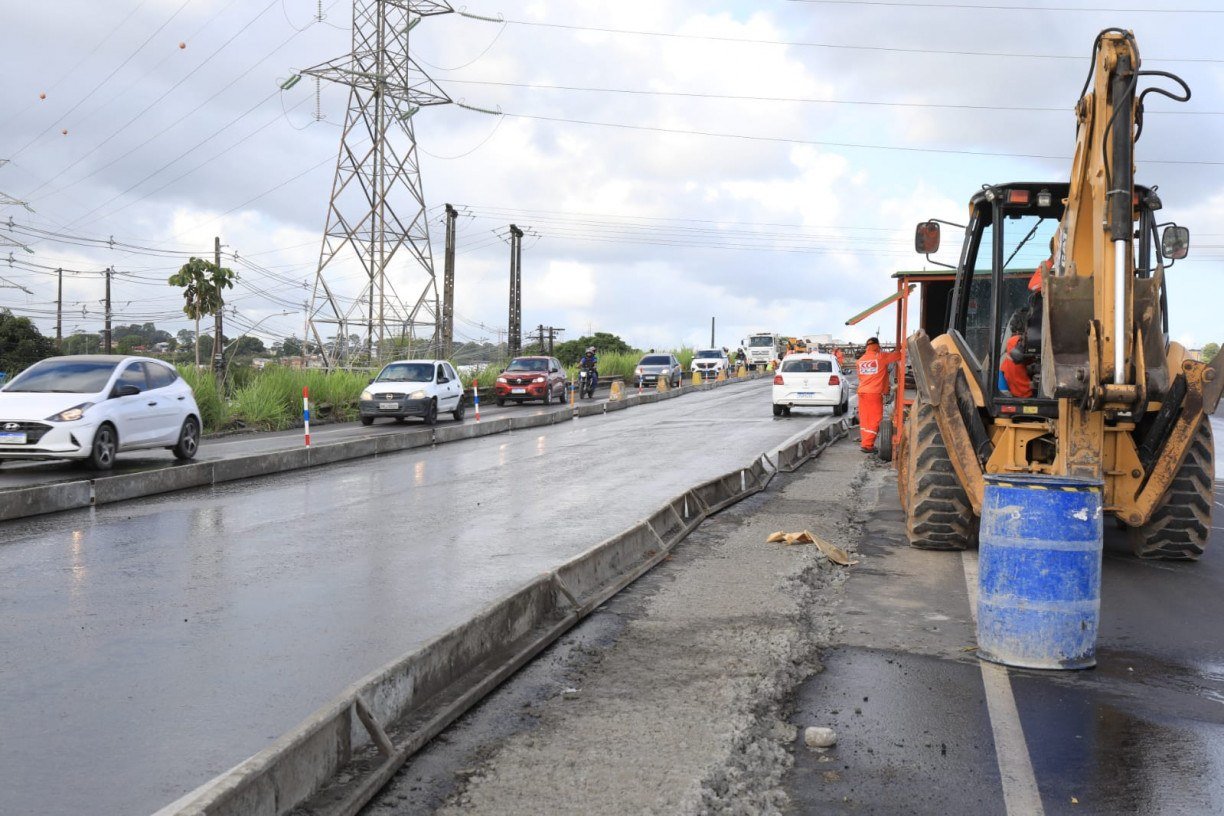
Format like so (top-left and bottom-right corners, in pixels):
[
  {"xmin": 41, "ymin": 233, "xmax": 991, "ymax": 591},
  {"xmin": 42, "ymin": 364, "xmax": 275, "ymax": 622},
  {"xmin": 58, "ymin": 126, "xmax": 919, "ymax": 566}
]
[{"xmin": 155, "ymin": 425, "xmax": 842, "ymax": 816}]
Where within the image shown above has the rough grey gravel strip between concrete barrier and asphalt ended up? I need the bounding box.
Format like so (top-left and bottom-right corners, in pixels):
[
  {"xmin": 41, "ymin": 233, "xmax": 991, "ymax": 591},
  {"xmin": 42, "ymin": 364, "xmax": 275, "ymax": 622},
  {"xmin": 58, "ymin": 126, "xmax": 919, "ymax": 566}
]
[{"xmin": 367, "ymin": 440, "xmax": 874, "ymax": 816}]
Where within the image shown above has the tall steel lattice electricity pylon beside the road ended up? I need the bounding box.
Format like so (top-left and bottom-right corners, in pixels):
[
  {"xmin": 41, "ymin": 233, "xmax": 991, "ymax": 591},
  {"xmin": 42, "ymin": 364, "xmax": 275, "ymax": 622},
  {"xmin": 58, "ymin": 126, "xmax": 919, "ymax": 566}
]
[{"xmin": 302, "ymin": 0, "xmax": 454, "ymax": 367}]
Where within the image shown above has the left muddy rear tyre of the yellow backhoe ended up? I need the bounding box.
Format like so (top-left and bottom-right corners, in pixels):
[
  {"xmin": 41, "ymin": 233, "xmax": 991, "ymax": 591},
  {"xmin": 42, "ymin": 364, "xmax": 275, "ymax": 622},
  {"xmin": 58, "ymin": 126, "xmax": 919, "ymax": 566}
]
[{"xmin": 903, "ymin": 399, "xmax": 973, "ymax": 549}]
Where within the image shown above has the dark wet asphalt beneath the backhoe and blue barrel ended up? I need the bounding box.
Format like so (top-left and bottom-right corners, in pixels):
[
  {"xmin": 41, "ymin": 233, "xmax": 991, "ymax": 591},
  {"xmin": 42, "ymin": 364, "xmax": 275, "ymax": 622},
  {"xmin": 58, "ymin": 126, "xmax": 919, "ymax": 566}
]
[{"xmin": 786, "ymin": 423, "xmax": 1224, "ymax": 816}]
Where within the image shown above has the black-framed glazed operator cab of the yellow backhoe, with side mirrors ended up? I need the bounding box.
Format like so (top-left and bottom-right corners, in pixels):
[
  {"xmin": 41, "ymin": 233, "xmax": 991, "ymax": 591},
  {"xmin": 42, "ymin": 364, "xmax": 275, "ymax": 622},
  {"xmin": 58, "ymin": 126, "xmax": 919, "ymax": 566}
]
[{"xmin": 914, "ymin": 182, "xmax": 1189, "ymax": 418}]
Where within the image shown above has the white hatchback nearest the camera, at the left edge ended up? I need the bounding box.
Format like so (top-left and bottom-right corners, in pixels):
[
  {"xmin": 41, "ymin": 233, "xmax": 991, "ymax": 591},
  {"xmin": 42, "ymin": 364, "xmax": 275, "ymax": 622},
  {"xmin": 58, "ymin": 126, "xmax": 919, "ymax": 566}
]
[{"xmin": 0, "ymin": 355, "xmax": 201, "ymax": 470}]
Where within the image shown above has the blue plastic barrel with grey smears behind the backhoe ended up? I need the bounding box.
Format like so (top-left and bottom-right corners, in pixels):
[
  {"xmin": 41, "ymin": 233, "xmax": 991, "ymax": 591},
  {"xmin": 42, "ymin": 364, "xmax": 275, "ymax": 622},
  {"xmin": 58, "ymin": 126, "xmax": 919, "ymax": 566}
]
[{"xmin": 978, "ymin": 475, "xmax": 1103, "ymax": 669}]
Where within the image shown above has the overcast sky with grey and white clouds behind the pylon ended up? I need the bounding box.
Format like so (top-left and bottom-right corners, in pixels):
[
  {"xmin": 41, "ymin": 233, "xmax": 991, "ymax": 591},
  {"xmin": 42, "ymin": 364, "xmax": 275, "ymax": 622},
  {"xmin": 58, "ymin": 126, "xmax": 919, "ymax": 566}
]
[{"xmin": 0, "ymin": 0, "xmax": 1224, "ymax": 347}]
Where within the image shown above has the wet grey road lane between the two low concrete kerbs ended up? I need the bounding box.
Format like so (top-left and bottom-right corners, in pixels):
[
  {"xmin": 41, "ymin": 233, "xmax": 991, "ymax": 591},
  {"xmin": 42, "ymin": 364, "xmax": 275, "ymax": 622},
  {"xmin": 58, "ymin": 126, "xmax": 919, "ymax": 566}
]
[{"xmin": 0, "ymin": 380, "xmax": 827, "ymax": 815}]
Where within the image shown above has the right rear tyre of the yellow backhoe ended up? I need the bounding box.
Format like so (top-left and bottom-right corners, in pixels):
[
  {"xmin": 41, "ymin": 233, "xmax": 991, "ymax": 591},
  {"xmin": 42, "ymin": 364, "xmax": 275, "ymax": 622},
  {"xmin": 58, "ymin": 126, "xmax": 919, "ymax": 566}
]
[{"xmin": 1130, "ymin": 417, "xmax": 1215, "ymax": 562}]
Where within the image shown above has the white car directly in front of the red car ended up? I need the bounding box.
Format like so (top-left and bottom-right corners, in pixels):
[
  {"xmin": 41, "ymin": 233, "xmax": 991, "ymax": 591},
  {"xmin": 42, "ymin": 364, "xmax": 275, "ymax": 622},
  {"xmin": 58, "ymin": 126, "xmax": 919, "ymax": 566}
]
[{"xmin": 360, "ymin": 360, "xmax": 466, "ymax": 425}]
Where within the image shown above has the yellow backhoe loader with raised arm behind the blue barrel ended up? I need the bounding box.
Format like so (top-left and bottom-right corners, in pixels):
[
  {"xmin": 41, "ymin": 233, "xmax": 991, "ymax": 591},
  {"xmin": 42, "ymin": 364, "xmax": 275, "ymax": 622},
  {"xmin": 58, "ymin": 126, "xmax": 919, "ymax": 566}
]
[{"xmin": 897, "ymin": 28, "xmax": 1224, "ymax": 559}]
